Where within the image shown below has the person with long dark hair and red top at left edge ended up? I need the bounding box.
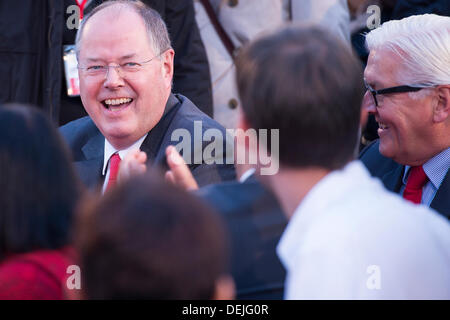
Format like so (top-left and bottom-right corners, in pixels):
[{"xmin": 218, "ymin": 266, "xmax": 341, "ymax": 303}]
[{"xmin": 0, "ymin": 105, "xmax": 81, "ymax": 299}]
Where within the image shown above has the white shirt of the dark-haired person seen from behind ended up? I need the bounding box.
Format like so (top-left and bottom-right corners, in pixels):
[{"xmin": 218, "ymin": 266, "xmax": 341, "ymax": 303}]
[{"xmin": 277, "ymin": 161, "xmax": 450, "ymax": 299}]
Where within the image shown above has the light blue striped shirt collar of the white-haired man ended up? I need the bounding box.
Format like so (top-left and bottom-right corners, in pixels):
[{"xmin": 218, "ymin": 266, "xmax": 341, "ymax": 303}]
[{"xmin": 403, "ymin": 148, "xmax": 450, "ymax": 189}]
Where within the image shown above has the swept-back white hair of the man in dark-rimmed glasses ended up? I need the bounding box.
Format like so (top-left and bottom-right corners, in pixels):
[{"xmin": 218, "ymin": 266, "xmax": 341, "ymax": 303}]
[{"xmin": 366, "ymin": 14, "xmax": 450, "ymax": 86}]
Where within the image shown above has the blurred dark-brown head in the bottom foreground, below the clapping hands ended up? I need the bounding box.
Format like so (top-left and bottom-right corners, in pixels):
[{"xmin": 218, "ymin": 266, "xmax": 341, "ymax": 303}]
[{"xmin": 76, "ymin": 175, "xmax": 234, "ymax": 299}]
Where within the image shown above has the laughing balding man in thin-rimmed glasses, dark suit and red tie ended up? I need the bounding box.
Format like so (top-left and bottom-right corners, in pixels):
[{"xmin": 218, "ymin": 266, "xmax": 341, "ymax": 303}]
[{"xmin": 61, "ymin": 1, "xmax": 234, "ymax": 190}]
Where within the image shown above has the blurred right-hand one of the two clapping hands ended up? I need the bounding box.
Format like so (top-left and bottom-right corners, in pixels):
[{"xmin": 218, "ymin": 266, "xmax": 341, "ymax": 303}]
[{"xmin": 165, "ymin": 146, "xmax": 198, "ymax": 190}]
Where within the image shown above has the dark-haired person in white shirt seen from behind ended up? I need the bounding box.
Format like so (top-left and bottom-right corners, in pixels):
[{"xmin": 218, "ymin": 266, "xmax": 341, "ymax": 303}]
[{"xmin": 163, "ymin": 27, "xmax": 450, "ymax": 299}]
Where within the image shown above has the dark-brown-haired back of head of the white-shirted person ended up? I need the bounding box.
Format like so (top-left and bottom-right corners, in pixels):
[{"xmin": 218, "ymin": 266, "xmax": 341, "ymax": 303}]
[{"xmin": 236, "ymin": 27, "xmax": 364, "ymax": 169}]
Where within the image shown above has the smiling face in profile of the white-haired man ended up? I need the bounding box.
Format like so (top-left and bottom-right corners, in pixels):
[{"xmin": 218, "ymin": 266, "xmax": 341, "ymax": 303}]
[{"xmin": 363, "ymin": 49, "xmax": 440, "ymax": 165}]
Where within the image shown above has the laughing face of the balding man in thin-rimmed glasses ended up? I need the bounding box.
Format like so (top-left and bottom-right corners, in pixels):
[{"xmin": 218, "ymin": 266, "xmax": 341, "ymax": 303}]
[{"xmin": 78, "ymin": 6, "xmax": 174, "ymax": 149}]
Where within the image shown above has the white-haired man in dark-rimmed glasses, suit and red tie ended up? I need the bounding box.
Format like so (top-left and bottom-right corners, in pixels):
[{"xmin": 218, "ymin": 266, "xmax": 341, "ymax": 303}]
[{"xmin": 361, "ymin": 14, "xmax": 450, "ymax": 218}]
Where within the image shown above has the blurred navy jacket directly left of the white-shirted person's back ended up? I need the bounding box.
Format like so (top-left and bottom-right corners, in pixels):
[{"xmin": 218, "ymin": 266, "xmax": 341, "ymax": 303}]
[{"xmin": 197, "ymin": 176, "xmax": 287, "ymax": 299}]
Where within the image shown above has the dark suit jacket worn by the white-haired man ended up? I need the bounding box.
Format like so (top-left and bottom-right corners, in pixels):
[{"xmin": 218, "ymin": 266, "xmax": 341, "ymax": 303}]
[{"xmin": 359, "ymin": 140, "xmax": 450, "ymax": 219}]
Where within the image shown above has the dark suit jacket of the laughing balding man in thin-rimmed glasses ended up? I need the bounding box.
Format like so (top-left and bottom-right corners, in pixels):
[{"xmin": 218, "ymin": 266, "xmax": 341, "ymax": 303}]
[{"xmin": 60, "ymin": 94, "xmax": 235, "ymax": 188}]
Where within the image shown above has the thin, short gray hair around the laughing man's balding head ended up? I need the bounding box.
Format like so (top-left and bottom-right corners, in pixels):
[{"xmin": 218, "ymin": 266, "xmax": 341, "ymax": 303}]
[{"xmin": 75, "ymin": 0, "xmax": 172, "ymax": 57}]
